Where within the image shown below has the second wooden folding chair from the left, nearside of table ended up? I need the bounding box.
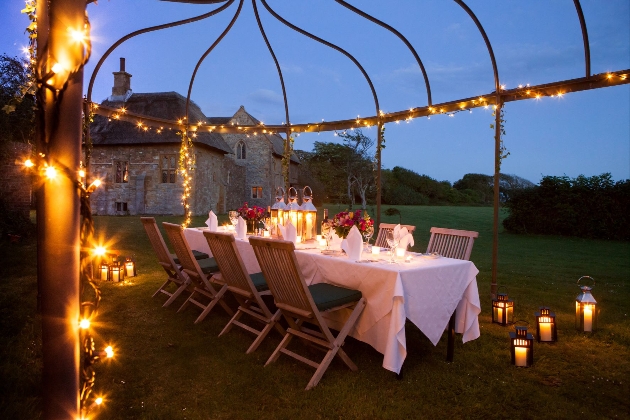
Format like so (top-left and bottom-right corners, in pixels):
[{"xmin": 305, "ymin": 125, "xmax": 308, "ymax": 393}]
[{"xmin": 162, "ymin": 222, "xmax": 234, "ymax": 324}]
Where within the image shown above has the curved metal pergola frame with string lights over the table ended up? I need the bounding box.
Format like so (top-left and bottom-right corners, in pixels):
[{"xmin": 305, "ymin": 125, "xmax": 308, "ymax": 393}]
[{"xmin": 37, "ymin": 0, "xmax": 630, "ymax": 418}]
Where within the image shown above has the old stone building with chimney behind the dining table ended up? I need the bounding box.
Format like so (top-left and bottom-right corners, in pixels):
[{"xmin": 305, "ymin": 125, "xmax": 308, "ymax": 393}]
[{"xmin": 89, "ymin": 58, "xmax": 299, "ymax": 215}]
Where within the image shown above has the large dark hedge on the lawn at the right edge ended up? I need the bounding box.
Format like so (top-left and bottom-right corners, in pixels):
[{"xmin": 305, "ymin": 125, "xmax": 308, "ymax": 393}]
[{"xmin": 503, "ymin": 173, "xmax": 630, "ymax": 240}]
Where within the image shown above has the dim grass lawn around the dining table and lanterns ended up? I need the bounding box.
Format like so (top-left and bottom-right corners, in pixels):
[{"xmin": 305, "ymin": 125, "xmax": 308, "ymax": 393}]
[{"xmin": 0, "ymin": 206, "xmax": 630, "ymax": 419}]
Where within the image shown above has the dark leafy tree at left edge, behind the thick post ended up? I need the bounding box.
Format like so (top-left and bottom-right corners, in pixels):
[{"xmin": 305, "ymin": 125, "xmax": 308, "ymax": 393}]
[{"xmin": 0, "ymin": 54, "xmax": 35, "ymax": 148}]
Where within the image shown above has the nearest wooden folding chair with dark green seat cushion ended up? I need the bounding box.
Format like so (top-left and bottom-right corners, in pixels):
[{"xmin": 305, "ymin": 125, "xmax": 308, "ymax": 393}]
[{"xmin": 249, "ymin": 237, "xmax": 366, "ymax": 390}]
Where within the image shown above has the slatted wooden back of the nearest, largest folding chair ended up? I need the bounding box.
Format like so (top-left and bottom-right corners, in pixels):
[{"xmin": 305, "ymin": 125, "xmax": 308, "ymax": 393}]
[{"xmin": 249, "ymin": 237, "xmax": 315, "ymax": 314}]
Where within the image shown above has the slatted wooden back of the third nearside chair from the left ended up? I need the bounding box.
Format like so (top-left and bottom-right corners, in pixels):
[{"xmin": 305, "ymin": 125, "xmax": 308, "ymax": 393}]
[{"xmin": 203, "ymin": 232, "xmax": 256, "ymax": 295}]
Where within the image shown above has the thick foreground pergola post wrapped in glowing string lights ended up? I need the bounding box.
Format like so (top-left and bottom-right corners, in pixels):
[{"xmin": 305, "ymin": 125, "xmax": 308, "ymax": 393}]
[{"xmin": 37, "ymin": 0, "xmax": 86, "ymax": 419}]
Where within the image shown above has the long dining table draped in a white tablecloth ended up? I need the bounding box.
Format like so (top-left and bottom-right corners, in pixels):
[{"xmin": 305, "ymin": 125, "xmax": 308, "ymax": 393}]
[{"xmin": 184, "ymin": 227, "xmax": 481, "ymax": 374}]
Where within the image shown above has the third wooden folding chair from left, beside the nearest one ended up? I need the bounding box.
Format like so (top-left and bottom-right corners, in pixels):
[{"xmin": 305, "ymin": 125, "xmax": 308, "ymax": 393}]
[{"xmin": 203, "ymin": 232, "xmax": 286, "ymax": 354}]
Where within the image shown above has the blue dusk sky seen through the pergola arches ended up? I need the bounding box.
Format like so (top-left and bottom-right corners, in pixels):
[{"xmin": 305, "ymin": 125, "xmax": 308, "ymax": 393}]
[{"xmin": 0, "ymin": 0, "xmax": 630, "ymax": 182}]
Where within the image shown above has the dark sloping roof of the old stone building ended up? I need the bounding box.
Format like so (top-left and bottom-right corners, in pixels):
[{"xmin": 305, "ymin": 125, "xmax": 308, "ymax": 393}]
[{"xmin": 90, "ymin": 92, "xmax": 232, "ymax": 153}]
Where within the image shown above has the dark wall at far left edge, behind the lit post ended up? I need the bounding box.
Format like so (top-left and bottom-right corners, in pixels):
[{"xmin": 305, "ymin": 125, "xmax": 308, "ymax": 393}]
[{"xmin": 0, "ymin": 142, "xmax": 32, "ymax": 215}]
